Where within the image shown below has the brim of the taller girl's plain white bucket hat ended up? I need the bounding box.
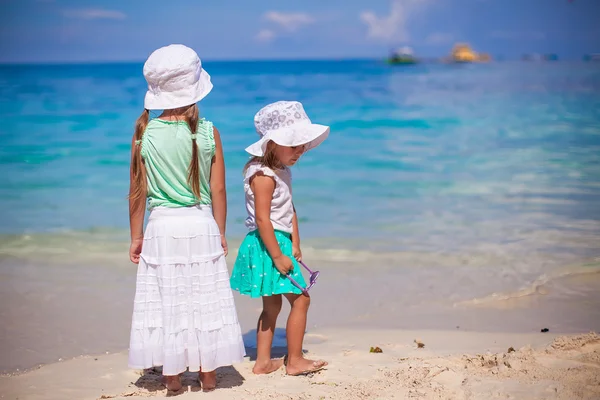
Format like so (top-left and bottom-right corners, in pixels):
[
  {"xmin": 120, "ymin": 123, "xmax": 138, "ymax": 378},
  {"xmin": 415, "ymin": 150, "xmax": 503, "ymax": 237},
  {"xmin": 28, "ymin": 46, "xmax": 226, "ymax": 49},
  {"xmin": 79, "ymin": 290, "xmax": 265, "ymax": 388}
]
[{"xmin": 144, "ymin": 69, "xmax": 213, "ymax": 110}]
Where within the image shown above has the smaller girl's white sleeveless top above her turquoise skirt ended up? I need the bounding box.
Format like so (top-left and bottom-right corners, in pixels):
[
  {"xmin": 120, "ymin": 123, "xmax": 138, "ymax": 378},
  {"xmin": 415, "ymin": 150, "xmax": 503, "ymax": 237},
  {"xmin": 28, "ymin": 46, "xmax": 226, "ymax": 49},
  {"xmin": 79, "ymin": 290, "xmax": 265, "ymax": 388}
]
[{"xmin": 244, "ymin": 163, "xmax": 294, "ymax": 233}]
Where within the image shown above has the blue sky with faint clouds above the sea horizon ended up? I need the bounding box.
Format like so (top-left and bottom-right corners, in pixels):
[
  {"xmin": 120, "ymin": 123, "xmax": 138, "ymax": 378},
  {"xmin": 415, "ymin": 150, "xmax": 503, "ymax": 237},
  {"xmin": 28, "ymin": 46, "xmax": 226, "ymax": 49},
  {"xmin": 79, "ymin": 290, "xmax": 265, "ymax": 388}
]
[{"xmin": 0, "ymin": 0, "xmax": 600, "ymax": 62}]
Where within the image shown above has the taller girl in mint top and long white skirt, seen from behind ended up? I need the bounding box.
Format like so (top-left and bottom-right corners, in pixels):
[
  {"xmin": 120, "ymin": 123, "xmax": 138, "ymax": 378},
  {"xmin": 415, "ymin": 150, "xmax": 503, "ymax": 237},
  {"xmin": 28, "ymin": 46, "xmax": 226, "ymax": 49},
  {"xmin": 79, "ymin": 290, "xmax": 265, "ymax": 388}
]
[{"xmin": 129, "ymin": 45, "xmax": 245, "ymax": 391}]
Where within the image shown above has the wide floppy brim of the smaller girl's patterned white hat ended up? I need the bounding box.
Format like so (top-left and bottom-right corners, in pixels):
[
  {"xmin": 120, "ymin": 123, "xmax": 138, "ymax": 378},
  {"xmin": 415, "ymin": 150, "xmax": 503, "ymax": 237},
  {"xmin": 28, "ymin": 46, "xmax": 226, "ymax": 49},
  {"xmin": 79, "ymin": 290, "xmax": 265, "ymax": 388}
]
[{"xmin": 246, "ymin": 124, "xmax": 329, "ymax": 157}]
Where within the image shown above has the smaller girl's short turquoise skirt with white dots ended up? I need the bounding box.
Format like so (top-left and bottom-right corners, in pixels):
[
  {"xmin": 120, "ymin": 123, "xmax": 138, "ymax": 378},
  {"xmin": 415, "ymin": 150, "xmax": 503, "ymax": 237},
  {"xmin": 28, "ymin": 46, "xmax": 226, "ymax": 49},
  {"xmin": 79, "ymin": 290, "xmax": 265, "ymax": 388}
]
[{"xmin": 230, "ymin": 230, "xmax": 306, "ymax": 297}]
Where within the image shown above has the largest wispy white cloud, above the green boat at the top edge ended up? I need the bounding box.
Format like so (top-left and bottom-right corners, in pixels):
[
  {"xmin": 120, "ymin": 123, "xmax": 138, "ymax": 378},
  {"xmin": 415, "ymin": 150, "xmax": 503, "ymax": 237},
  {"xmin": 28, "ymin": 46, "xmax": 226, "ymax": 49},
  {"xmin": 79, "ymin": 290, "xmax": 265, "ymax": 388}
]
[{"xmin": 360, "ymin": 0, "xmax": 426, "ymax": 42}]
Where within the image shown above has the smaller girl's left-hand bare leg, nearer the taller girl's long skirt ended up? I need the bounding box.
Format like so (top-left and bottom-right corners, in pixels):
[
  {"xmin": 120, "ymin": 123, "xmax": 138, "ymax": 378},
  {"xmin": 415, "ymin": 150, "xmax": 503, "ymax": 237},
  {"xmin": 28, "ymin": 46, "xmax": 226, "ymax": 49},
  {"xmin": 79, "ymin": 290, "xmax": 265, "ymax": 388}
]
[{"xmin": 252, "ymin": 294, "xmax": 283, "ymax": 374}]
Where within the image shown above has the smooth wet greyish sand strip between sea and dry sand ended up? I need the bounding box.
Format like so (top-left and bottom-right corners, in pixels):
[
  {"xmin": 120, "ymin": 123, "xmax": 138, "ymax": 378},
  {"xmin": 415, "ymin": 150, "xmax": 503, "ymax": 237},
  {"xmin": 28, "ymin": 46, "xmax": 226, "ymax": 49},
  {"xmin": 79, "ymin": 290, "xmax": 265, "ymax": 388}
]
[{"xmin": 0, "ymin": 251, "xmax": 600, "ymax": 374}]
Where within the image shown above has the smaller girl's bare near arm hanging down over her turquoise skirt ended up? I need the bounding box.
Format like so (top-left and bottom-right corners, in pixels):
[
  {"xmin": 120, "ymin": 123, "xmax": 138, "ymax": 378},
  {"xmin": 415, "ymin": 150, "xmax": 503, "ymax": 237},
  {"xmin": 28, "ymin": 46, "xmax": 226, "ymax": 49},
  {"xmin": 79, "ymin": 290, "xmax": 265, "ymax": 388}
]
[{"xmin": 250, "ymin": 175, "xmax": 294, "ymax": 275}]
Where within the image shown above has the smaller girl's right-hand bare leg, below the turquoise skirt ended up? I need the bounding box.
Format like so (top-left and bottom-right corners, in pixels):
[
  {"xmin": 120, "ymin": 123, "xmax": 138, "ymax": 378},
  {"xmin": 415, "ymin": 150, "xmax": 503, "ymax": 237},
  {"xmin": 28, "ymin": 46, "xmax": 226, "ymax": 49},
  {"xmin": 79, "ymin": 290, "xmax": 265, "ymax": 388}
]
[{"xmin": 285, "ymin": 293, "xmax": 327, "ymax": 375}]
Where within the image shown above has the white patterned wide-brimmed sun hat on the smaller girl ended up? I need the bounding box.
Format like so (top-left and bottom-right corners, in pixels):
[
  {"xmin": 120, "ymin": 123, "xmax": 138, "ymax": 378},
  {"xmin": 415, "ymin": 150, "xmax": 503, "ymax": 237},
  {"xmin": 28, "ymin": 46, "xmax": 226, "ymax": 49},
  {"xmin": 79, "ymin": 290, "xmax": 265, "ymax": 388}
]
[{"xmin": 246, "ymin": 101, "xmax": 329, "ymax": 157}]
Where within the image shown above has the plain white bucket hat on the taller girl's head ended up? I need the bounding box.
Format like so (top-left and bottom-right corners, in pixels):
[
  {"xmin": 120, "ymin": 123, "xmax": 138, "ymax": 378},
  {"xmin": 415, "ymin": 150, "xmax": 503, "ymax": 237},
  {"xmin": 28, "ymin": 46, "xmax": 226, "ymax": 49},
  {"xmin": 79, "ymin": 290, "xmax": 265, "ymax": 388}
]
[{"xmin": 144, "ymin": 44, "xmax": 213, "ymax": 110}]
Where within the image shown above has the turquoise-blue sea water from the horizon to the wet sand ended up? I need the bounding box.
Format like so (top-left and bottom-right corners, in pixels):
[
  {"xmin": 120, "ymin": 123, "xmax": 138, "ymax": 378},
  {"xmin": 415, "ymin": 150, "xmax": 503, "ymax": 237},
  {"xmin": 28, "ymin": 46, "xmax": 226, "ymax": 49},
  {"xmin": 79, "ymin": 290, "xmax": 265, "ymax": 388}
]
[{"xmin": 0, "ymin": 60, "xmax": 600, "ymax": 290}]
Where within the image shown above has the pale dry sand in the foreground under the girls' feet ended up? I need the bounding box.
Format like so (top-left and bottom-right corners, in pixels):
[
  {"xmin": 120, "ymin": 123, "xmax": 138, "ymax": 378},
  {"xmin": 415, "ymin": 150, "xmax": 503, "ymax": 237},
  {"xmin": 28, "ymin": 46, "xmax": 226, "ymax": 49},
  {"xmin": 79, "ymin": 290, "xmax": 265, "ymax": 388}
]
[{"xmin": 0, "ymin": 329, "xmax": 600, "ymax": 400}]
